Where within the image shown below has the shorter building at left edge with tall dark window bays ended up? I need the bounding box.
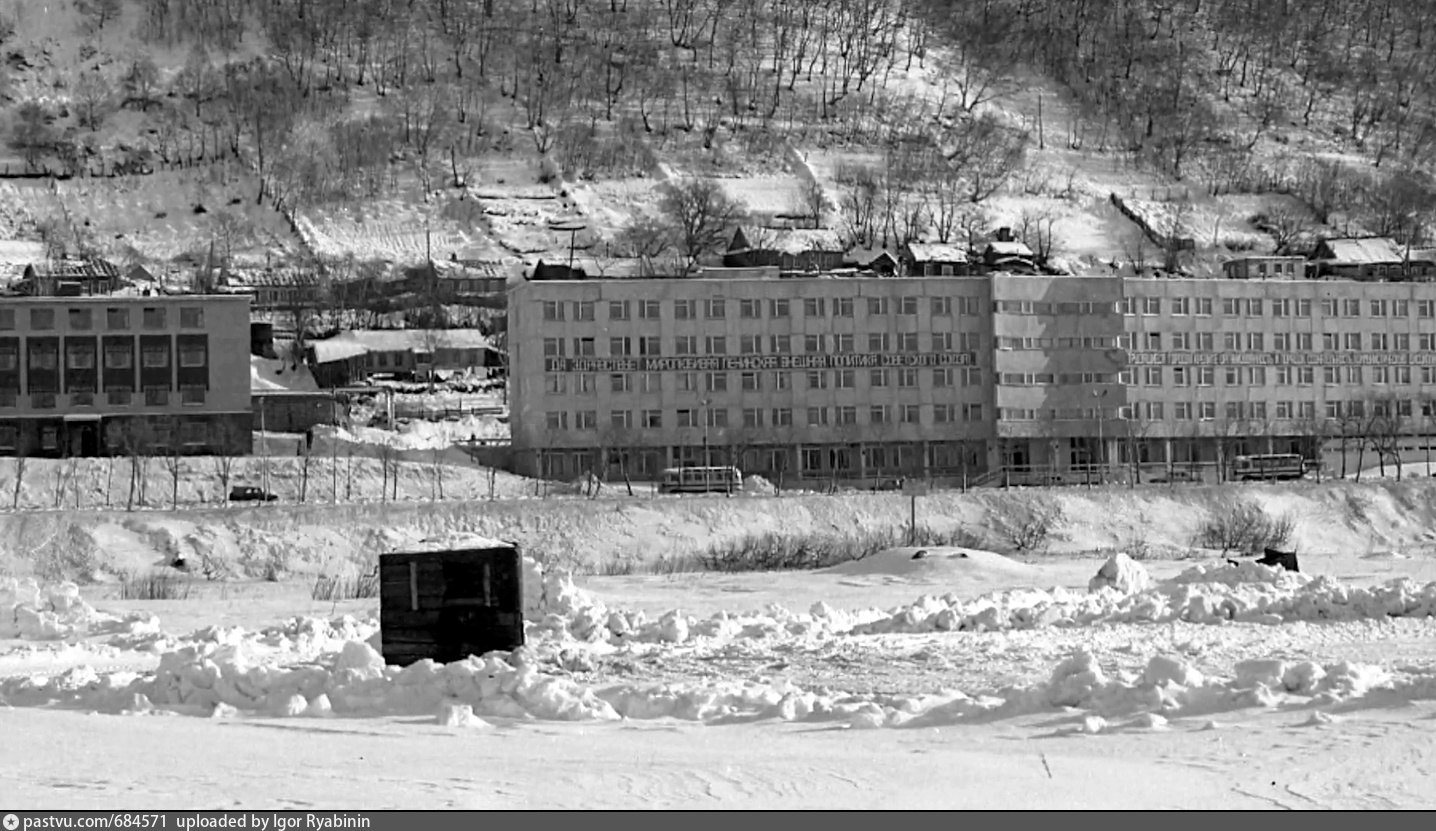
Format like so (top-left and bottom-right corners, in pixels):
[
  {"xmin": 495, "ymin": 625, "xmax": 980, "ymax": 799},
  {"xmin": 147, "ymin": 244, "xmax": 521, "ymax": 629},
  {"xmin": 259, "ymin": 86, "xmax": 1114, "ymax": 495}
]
[{"xmin": 0, "ymin": 294, "xmax": 251, "ymax": 456}]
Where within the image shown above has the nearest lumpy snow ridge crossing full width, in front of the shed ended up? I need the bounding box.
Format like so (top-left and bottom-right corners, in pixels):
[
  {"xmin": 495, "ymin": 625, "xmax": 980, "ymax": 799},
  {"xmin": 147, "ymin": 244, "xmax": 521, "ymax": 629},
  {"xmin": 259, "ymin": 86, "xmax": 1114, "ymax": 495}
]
[{"xmin": 0, "ymin": 642, "xmax": 1418, "ymax": 733}]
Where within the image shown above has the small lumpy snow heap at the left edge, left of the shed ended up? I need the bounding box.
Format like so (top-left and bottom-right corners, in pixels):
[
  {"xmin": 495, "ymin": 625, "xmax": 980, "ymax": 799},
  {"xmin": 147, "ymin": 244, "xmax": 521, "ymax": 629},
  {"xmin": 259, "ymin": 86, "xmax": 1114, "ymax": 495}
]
[{"xmin": 0, "ymin": 578, "xmax": 159, "ymax": 640}]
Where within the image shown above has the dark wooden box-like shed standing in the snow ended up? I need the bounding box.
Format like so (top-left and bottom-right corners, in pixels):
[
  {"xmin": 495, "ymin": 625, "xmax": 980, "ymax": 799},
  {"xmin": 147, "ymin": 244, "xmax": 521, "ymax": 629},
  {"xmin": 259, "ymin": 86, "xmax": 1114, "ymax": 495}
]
[{"xmin": 379, "ymin": 538, "xmax": 524, "ymax": 666}]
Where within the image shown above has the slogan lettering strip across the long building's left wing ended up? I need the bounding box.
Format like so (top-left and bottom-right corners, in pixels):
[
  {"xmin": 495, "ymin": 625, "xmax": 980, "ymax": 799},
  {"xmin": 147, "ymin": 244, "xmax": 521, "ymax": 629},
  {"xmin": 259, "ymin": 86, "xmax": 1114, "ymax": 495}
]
[{"xmin": 544, "ymin": 352, "xmax": 976, "ymax": 372}]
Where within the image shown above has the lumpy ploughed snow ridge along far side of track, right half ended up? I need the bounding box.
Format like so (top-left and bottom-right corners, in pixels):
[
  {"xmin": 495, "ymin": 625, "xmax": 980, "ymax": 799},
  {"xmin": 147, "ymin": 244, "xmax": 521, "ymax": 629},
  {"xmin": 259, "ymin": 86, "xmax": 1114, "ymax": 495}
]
[{"xmin": 852, "ymin": 563, "xmax": 1436, "ymax": 634}]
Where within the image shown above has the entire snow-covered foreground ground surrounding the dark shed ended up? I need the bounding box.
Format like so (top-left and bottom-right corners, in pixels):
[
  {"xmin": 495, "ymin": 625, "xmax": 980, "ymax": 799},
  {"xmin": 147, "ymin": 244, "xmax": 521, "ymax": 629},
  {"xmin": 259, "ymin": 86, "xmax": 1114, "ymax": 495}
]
[{"xmin": 0, "ymin": 482, "xmax": 1436, "ymax": 808}]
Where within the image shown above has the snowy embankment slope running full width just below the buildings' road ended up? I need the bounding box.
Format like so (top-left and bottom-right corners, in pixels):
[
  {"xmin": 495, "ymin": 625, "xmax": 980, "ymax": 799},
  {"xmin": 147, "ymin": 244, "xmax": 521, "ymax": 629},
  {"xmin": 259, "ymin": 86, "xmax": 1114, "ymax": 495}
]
[{"xmin": 8, "ymin": 479, "xmax": 1436, "ymax": 581}]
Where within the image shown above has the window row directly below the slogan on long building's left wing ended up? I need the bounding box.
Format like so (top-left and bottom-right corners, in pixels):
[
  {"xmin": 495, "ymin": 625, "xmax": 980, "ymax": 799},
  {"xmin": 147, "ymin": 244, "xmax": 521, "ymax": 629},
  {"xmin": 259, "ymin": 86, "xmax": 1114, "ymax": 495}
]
[{"xmin": 544, "ymin": 366, "xmax": 987, "ymax": 395}]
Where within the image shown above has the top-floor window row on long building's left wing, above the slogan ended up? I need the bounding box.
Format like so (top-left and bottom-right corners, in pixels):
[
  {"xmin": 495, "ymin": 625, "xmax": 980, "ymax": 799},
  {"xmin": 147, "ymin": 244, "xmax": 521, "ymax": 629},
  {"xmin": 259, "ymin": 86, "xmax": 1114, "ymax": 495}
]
[{"xmin": 541, "ymin": 297, "xmax": 984, "ymax": 321}]
